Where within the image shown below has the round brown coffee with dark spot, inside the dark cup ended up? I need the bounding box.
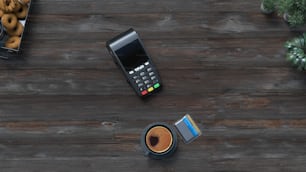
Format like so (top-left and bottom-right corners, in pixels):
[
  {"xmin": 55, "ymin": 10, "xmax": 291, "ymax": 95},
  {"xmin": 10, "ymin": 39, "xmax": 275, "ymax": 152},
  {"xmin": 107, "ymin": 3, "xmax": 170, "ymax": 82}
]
[{"xmin": 146, "ymin": 126, "xmax": 173, "ymax": 153}]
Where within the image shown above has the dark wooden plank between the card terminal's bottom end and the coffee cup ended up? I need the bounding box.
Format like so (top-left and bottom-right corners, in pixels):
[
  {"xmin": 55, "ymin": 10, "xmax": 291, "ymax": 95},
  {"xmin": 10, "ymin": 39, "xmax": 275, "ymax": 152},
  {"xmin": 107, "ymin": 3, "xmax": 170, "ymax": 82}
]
[{"xmin": 0, "ymin": 93, "xmax": 305, "ymax": 121}]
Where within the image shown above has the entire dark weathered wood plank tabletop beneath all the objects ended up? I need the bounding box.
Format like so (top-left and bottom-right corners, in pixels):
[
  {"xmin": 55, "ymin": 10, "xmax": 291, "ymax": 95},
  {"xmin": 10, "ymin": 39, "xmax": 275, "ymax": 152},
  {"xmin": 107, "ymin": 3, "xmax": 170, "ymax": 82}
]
[{"xmin": 0, "ymin": 0, "xmax": 306, "ymax": 172}]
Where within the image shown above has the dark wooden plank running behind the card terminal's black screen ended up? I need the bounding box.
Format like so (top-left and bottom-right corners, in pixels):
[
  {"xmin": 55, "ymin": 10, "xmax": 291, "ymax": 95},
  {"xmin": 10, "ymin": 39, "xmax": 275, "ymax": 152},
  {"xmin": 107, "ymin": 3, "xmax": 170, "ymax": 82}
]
[{"xmin": 0, "ymin": 38, "xmax": 290, "ymax": 70}]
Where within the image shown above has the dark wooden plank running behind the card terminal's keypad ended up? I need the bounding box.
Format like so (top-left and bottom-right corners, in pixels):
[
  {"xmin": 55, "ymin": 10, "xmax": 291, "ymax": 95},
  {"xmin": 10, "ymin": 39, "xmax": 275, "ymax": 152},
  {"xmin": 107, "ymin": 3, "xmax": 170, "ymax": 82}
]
[{"xmin": 0, "ymin": 68, "xmax": 305, "ymax": 96}]
